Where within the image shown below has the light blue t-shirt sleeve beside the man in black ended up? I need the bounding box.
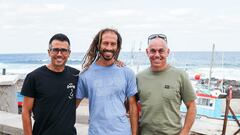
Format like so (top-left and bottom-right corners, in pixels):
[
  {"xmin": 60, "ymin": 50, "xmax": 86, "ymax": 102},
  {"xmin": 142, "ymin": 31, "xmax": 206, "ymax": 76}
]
[{"xmin": 76, "ymin": 74, "xmax": 88, "ymax": 99}]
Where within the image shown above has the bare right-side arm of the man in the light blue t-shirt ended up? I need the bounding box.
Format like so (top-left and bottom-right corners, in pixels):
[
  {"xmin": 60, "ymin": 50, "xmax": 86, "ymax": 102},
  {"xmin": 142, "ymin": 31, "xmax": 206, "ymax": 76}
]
[{"xmin": 129, "ymin": 96, "xmax": 138, "ymax": 135}]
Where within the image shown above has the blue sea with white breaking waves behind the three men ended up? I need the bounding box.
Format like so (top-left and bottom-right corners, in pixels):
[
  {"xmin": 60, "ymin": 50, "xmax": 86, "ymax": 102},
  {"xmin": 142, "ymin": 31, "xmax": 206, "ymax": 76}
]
[{"xmin": 0, "ymin": 51, "xmax": 240, "ymax": 80}]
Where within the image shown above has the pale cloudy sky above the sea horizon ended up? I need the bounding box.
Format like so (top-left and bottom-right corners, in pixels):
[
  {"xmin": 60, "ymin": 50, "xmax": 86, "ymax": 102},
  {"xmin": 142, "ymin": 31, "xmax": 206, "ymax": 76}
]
[{"xmin": 0, "ymin": 0, "xmax": 240, "ymax": 54}]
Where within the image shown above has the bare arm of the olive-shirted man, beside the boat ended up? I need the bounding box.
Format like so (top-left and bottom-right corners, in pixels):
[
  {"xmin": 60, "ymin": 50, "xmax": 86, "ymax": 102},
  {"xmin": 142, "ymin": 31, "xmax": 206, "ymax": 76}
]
[{"xmin": 180, "ymin": 100, "xmax": 196, "ymax": 135}]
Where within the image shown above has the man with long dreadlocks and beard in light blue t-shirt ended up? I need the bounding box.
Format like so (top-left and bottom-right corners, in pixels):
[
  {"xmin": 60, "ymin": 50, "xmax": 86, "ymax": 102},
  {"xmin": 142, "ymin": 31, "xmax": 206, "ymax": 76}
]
[{"xmin": 76, "ymin": 28, "xmax": 138, "ymax": 135}]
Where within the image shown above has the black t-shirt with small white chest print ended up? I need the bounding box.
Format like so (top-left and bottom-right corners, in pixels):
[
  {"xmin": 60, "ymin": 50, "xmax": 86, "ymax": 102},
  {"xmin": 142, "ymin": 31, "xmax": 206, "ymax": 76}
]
[{"xmin": 21, "ymin": 66, "xmax": 79, "ymax": 135}]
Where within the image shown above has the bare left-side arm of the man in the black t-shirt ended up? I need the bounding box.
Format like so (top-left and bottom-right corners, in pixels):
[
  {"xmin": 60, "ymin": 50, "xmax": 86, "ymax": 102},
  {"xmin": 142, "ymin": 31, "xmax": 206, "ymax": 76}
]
[{"xmin": 22, "ymin": 96, "xmax": 34, "ymax": 135}]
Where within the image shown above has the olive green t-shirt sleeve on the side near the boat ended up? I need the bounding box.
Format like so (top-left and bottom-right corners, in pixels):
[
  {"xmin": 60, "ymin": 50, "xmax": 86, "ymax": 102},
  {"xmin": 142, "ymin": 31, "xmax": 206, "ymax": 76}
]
[{"xmin": 181, "ymin": 72, "xmax": 197, "ymax": 103}]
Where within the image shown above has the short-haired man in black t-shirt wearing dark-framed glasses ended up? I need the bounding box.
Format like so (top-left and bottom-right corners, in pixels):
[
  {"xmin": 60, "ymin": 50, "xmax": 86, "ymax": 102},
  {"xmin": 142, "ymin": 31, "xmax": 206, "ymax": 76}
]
[{"xmin": 21, "ymin": 34, "xmax": 79, "ymax": 135}]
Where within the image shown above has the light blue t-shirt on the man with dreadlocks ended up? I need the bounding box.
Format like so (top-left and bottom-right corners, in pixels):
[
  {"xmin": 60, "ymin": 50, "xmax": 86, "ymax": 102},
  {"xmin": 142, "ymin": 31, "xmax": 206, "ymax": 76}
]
[{"xmin": 76, "ymin": 63, "xmax": 137, "ymax": 135}]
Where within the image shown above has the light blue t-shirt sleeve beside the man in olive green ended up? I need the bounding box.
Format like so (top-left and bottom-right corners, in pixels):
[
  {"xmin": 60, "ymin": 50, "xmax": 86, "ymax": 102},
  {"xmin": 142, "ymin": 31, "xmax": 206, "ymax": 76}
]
[{"xmin": 126, "ymin": 69, "xmax": 137, "ymax": 97}]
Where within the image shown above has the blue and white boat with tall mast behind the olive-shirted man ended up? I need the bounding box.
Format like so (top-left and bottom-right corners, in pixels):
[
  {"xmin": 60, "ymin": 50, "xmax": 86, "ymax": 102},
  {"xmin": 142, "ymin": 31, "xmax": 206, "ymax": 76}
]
[{"xmin": 180, "ymin": 45, "xmax": 240, "ymax": 135}]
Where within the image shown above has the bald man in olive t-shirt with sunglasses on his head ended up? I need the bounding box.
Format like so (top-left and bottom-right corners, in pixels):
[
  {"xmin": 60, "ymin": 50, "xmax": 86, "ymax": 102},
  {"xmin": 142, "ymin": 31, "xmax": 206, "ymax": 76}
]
[{"xmin": 137, "ymin": 34, "xmax": 196, "ymax": 135}]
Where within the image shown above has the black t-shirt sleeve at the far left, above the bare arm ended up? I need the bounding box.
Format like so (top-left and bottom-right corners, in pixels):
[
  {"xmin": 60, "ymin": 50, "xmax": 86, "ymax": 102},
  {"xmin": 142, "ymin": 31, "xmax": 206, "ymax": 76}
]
[{"xmin": 21, "ymin": 73, "xmax": 36, "ymax": 98}]
